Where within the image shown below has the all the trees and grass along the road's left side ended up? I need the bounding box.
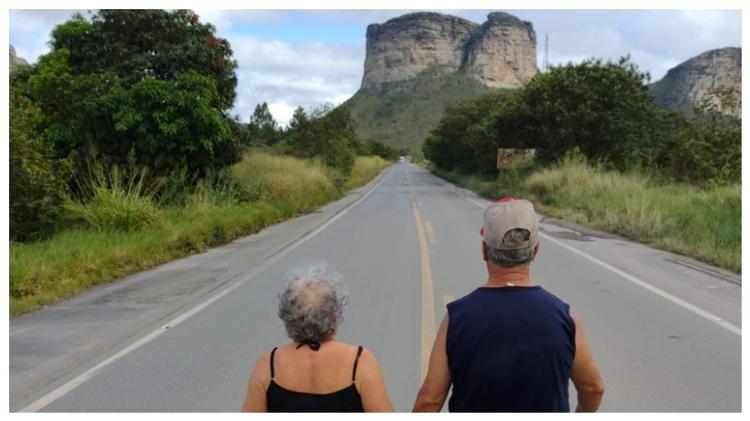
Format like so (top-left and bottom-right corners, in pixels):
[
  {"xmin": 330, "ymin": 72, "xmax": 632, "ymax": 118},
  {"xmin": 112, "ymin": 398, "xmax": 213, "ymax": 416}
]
[{"xmin": 9, "ymin": 10, "xmax": 397, "ymax": 314}]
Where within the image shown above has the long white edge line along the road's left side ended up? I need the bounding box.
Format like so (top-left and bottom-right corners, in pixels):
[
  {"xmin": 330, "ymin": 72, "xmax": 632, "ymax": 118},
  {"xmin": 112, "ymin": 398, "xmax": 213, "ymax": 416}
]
[{"xmin": 20, "ymin": 170, "xmax": 391, "ymax": 412}]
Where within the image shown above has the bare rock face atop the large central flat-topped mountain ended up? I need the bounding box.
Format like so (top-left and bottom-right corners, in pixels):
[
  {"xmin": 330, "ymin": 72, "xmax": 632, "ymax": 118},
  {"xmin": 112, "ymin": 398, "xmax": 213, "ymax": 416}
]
[{"xmin": 362, "ymin": 12, "xmax": 537, "ymax": 89}]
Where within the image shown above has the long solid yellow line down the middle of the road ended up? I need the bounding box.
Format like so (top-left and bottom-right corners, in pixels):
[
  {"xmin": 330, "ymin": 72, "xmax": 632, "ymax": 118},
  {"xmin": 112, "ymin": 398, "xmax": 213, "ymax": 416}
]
[{"xmin": 406, "ymin": 166, "xmax": 435, "ymax": 380}]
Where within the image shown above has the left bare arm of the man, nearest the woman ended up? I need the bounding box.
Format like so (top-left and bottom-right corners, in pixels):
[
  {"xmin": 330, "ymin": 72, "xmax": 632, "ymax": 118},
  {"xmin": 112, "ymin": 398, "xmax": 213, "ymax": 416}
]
[{"xmin": 412, "ymin": 313, "xmax": 451, "ymax": 412}]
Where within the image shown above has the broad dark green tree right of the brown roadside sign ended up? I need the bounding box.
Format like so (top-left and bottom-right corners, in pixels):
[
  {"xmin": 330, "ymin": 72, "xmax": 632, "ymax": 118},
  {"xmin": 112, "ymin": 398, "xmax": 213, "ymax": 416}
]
[{"xmin": 516, "ymin": 57, "xmax": 654, "ymax": 169}]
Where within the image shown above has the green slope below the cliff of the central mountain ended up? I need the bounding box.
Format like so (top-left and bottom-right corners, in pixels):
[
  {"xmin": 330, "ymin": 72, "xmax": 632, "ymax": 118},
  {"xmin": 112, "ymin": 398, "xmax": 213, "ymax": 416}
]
[{"xmin": 344, "ymin": 68, "xmax": 492, "ymax": 150}]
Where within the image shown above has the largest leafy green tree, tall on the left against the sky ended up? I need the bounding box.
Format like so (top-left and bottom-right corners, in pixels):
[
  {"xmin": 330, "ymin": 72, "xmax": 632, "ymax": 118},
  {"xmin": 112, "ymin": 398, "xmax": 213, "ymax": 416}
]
[{"xmin": 16, "ymin": 10, "xmax": 240, "ymax": 179}]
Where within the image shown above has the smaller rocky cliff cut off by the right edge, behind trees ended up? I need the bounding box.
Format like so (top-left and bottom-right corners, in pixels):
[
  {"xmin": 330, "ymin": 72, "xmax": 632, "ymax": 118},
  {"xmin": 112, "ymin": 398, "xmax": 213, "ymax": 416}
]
[{"xmin": 651, "ymin": 47, "xmax": 742, "ymax": 116}]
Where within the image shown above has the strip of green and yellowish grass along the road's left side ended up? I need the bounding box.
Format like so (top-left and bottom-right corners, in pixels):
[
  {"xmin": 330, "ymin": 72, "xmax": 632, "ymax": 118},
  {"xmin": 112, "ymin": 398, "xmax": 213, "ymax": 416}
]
[{"xmin": 9, "ymin": 151, "xmax": 388, "ymax": 314}]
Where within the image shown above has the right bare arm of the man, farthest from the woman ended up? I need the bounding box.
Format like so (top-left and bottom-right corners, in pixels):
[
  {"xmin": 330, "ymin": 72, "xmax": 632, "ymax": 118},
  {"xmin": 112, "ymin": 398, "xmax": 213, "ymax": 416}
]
[{"xmin": 570, "ymin": 314, "xmax": 604, "ymax": 412}]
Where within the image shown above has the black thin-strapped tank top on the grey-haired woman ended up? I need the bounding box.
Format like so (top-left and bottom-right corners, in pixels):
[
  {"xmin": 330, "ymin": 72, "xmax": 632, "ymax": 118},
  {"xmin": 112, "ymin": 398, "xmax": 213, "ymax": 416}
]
[{"xmin": 266, "ymin": 346, "xmax": 364, "ymax": 412}]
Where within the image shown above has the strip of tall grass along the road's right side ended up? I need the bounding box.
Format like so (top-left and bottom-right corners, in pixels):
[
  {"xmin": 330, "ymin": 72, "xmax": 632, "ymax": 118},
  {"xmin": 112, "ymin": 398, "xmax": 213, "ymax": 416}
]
[{"xmin": 436, "ymin": 158, "xmax": 742, "ymax": 272}]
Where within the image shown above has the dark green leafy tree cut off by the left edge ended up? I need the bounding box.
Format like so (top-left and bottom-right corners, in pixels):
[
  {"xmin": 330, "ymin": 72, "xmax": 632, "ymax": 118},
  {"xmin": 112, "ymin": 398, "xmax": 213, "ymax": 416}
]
[{"xmin": 9, "ymin": 89, "xmax": 70, "ymax": 241}]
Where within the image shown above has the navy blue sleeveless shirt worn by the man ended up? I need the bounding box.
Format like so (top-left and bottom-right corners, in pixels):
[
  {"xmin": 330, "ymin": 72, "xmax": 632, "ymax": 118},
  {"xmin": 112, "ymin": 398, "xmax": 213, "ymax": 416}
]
[{"xmin": 446, "ymin": 286, "xmax": 576, "ymax": 412}]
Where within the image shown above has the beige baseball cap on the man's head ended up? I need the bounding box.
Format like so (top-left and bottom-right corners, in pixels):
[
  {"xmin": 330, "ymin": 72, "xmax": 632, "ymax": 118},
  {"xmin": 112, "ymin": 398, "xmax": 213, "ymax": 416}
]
[{"xmin": 480, "ymin": 196, "xmax": 539, "ymax": 250}]
